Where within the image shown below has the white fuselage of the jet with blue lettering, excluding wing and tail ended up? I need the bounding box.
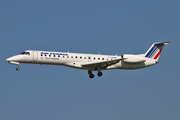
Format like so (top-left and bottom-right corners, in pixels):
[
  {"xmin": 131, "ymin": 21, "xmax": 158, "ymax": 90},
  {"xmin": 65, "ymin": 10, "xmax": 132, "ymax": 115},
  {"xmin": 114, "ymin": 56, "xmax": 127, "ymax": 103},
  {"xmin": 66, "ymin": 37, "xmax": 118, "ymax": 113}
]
[{"xmin": 7, "ymin": 50, "xmax": 156, "ymax": 71}]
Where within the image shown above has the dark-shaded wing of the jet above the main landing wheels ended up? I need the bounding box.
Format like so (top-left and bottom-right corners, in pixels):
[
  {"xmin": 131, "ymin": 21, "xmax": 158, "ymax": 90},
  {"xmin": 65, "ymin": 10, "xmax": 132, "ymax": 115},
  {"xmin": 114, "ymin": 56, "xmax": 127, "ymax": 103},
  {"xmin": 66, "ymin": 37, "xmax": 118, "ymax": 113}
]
[{"xmin": 81, "ymin": 58, "xmax": 126, "ymax": 69}]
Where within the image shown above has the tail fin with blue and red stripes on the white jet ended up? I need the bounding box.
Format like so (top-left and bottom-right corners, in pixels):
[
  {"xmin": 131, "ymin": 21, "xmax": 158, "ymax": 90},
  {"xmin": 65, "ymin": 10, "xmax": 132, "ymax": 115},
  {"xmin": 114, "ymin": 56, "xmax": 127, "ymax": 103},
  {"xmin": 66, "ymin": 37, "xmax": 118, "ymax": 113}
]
[{"xmin": 145, "ymin": 41, "xmax": 172, "ymax": 60}]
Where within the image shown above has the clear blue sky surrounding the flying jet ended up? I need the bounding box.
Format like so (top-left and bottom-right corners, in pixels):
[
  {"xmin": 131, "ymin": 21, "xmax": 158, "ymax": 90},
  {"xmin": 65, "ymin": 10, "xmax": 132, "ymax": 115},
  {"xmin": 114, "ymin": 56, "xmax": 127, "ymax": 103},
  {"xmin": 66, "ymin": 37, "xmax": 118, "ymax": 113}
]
[{"xmin": 0, "ymin": 0, "xmax": 180, "ymax": 120}]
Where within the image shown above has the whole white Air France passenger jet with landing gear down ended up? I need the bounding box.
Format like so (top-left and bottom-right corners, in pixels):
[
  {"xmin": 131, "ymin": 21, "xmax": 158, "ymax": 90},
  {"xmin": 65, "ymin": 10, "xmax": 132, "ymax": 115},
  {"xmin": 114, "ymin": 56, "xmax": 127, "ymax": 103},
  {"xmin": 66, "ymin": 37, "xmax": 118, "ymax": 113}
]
[{"xmin": 6, "ymin": 41, "xmax": 172, "ymax": 78}]
